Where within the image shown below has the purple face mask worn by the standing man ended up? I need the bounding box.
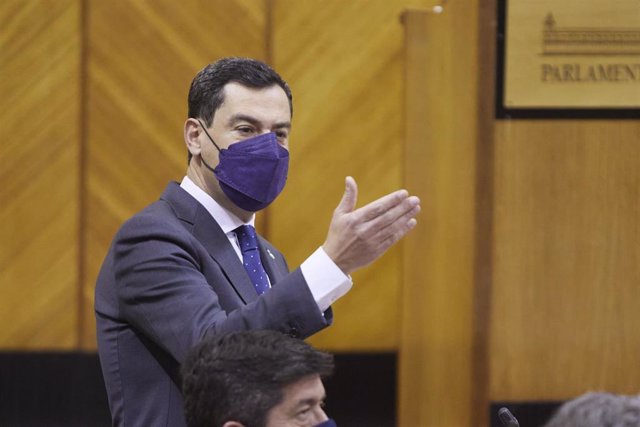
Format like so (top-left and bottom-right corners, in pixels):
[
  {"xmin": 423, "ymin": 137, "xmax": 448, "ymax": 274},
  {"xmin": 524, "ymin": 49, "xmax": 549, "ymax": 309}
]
[{"xmin": 198, "ymin": 120, "xmax": 289, "ymax": 212}]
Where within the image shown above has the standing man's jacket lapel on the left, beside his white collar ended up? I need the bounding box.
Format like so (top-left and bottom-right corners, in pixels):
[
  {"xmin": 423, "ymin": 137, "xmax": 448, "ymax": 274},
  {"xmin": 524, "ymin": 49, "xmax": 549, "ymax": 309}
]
[{"xmin": 162, "ymin": 183, "xmax": 258, "ymax": 304}]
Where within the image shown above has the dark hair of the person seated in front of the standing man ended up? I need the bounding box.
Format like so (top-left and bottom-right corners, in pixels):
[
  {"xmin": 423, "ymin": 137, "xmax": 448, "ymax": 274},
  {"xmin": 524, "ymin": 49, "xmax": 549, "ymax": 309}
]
[{"xmin": 181, "ymin": 331, "xmax": 333, "ymax": 427}]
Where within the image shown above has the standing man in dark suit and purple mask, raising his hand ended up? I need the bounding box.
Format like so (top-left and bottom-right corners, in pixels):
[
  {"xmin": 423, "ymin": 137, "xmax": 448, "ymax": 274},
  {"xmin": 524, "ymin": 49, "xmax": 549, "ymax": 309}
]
[{"xmin": 95, "ymin": 58, "xmax": 420, "ymax": 426}]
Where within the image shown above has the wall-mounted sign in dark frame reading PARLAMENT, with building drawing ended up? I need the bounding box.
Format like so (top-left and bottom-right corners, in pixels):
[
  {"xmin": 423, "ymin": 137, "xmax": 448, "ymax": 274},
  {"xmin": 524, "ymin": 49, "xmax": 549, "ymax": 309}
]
[{"xmin": 497, "ymin": 0, "xmax": 640, "ymax": 118}]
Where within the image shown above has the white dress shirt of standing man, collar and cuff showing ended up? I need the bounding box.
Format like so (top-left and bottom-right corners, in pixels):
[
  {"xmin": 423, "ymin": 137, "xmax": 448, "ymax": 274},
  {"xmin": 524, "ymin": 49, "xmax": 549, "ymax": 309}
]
[{"xmin": 180, "ymin": 176, "xmax": 353, "ymax": 312}]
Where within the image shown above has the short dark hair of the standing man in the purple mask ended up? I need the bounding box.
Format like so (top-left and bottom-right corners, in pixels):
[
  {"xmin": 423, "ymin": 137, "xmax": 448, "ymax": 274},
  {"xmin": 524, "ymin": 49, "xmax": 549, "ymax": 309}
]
[{"xmin": 188, "ymin": 57, "xmax": 293, "ymax": 126}]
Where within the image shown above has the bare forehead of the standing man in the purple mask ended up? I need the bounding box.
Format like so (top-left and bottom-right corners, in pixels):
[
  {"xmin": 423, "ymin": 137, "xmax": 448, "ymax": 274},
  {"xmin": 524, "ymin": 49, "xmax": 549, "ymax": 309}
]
[{"xmin": 214, "ymin": 82, "xmax": 291, "ymax": 122}]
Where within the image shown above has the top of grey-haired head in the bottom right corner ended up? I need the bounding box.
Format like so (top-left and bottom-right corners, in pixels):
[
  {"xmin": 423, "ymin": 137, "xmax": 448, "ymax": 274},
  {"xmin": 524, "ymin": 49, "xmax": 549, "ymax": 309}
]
[{"xmin": 545, "ymin": 392, "xmax": 640, "ymax": 427}]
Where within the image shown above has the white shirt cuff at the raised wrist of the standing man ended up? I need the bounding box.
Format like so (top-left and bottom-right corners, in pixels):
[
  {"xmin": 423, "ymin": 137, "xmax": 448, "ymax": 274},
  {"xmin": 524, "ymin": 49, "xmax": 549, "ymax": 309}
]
[{"xmin": 300, "ymin": 247, "xmax": 353, "ymax": 312}]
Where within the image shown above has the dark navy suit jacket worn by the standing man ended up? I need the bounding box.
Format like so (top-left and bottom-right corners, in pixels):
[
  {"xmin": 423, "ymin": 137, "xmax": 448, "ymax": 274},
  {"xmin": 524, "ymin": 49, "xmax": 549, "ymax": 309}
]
[{"xmin": 95, "ymin": 183, "xmax": 332, "ymax": 427}]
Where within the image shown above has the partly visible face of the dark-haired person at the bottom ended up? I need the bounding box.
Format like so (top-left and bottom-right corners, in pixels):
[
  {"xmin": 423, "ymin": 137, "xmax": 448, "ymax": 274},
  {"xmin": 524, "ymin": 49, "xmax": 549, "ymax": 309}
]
[{"xmin": 267, "ymin": 375, "xmax": 327, "ymax": 427}]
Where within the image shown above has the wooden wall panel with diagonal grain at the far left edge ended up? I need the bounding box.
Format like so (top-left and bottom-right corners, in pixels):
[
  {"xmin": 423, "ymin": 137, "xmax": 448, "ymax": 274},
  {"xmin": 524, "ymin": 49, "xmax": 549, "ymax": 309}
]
[{"xmin": 0, "ymin": 0, "xmax": 80, "ymax": 350}]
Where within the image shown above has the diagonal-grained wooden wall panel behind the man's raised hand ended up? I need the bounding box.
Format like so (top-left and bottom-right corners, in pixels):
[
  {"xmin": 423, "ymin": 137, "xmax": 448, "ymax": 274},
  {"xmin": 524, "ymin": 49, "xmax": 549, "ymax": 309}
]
[{"xmin": 269, "ymin": 0, "xmax": 430, "ymax": 351}]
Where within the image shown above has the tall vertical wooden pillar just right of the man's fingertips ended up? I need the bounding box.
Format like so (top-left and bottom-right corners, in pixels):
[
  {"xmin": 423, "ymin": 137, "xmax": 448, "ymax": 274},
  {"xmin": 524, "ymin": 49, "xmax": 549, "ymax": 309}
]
[{"xmin": 399, "ymin": 2, "xmax": 478, "ymax": 427}]
